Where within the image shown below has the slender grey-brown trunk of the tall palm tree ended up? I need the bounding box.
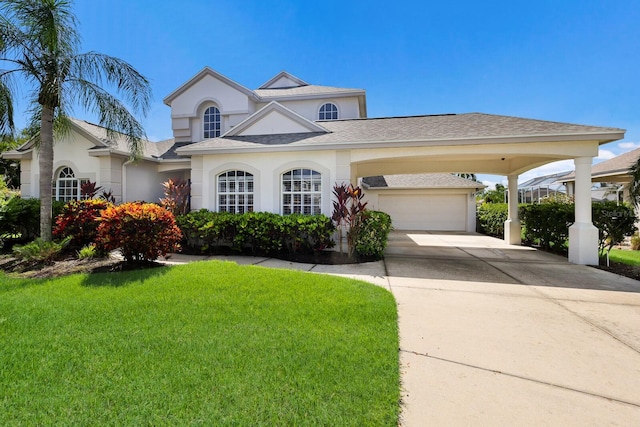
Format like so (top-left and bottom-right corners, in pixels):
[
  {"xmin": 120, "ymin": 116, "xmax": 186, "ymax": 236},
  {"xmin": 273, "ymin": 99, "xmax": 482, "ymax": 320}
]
[{"xmin": 39, "ymin": 105, "xmax": 53, "ymax": 242}]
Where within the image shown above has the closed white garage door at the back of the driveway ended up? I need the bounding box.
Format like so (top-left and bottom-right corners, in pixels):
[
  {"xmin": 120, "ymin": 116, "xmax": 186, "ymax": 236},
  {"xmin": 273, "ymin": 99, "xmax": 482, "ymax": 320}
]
[{"xmin": 378, "ymin": 194, "xmax": 467, "ymax": 231}]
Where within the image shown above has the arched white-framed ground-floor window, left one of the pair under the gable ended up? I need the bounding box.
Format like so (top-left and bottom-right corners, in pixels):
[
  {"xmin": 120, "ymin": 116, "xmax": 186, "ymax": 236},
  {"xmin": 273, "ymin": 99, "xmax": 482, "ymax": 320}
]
[{"xmin": 218, "ymin": 170, "xmax": 253, "ymax": 213}]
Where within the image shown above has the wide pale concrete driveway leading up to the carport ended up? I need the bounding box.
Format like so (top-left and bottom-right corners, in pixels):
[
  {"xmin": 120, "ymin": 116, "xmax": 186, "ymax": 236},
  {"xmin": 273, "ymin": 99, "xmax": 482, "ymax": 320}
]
[{"xmin": 385, "ymin": 231, "xmax": 640, "ymax": 426}]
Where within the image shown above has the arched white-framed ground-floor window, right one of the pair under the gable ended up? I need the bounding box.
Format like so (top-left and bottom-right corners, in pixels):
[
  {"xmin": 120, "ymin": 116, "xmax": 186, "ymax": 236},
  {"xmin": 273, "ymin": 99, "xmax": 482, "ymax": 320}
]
[{"xmin": 282, "ymin": 169, "xmax": 322, "ymax": 215}]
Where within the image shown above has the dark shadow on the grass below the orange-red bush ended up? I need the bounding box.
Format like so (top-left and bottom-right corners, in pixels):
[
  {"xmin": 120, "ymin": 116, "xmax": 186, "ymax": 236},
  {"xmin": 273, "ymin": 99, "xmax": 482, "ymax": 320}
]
[{"xmin": 82, "ymin": 261, "xmax": 170, "ymax": 287}]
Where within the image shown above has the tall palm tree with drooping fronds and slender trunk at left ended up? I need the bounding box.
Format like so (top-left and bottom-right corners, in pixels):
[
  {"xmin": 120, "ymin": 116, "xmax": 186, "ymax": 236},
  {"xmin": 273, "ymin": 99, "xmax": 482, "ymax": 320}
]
[{"xmin": 0, "ymin": 0, "xmax": 151, "ymax": 241}]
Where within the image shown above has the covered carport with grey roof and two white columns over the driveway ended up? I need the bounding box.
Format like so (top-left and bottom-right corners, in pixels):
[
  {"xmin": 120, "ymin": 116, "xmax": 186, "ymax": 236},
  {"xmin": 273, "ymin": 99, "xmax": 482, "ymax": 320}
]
[{"xmin": 340, "ymin": 113, "xmax": 625, "ymax": 264}]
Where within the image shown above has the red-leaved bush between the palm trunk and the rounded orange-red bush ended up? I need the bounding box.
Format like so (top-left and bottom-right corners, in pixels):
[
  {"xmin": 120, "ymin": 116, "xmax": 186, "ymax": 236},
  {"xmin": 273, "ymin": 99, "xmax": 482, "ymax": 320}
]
[{"xmin": 53, "ymin": 199, "xmax": 113, "ymax": 249}]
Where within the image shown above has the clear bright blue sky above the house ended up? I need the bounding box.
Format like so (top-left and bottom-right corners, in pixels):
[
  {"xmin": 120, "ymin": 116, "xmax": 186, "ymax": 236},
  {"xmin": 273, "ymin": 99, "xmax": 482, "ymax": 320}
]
[{"xmin": 11, "ymin": 0, "xmax": 640, "ymax": 186}]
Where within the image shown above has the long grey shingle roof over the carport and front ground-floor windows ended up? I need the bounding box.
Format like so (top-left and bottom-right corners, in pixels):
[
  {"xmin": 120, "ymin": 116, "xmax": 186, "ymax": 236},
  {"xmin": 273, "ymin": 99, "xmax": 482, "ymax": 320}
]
[{"xmin": 180, "ymin": 113, "xmax": 624, "ymax": 151}]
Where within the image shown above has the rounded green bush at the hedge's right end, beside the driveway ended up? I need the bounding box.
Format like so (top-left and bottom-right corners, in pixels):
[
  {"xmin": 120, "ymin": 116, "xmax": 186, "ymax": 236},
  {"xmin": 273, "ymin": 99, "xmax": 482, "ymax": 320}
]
[{"xmin": 349, "ymin": 210, "xmax": 392, "ymax": 260}]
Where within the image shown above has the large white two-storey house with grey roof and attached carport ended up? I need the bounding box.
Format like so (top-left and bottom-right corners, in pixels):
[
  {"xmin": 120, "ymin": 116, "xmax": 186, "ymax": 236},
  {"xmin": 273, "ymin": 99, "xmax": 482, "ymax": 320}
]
[{"xmin": 3, "ymin": 67, "xmax": 624, "ymax": 263}]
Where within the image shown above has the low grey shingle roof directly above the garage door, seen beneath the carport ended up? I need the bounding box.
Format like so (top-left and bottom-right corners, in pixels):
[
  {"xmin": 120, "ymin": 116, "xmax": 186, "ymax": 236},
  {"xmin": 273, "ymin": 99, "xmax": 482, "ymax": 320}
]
[{"xmin": 362, "ymin": 173, "xmax": 486, "ymax": 189}]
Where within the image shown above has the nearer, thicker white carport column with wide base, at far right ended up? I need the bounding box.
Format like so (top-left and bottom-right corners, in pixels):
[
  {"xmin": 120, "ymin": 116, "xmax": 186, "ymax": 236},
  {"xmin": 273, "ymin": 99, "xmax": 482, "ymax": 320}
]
[{"xmin": 569, "ymin": 157, "xmax": 598, "ymax": 265}]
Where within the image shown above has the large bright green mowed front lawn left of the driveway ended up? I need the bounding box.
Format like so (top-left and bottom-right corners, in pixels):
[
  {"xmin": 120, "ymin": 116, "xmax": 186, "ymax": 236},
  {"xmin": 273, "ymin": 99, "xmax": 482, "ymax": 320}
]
[{"xmin": 0, "ymin": 261, "xmax": 400, "ymax": 426}]
